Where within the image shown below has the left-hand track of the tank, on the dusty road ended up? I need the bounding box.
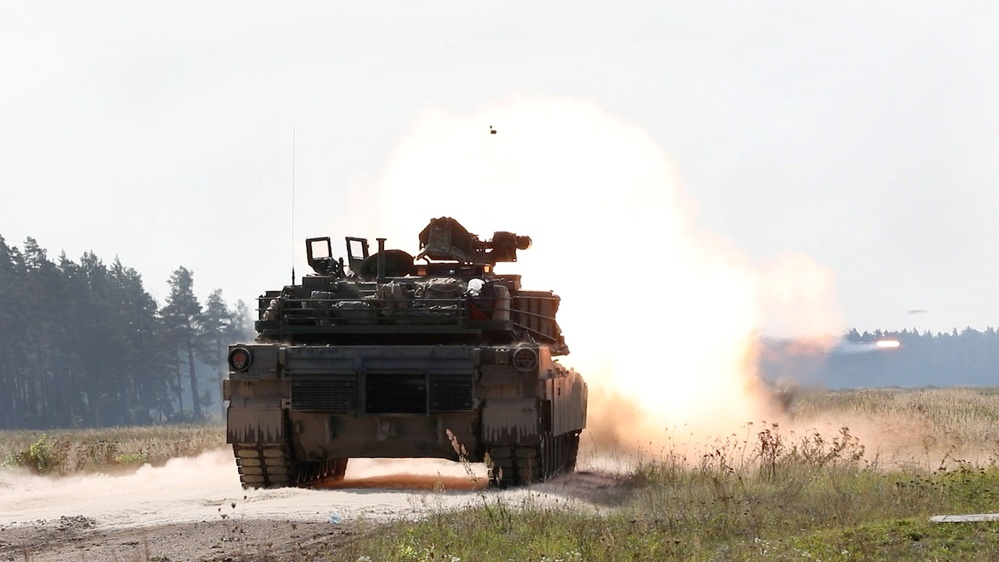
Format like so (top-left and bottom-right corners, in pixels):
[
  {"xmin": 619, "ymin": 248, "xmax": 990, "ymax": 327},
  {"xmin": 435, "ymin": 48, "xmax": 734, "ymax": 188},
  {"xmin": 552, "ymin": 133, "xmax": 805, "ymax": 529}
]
[{"xmin": 232, "ymin": 443, "xmax": 348, "ymax": 488}]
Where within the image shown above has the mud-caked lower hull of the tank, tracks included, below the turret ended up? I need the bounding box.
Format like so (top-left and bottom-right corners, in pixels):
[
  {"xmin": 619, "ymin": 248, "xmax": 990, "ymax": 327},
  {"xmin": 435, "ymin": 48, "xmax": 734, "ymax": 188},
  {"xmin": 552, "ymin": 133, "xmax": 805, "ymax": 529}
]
[{"xmin": 225, "ymin": 344, "xmax": 587, "ymax": 487}]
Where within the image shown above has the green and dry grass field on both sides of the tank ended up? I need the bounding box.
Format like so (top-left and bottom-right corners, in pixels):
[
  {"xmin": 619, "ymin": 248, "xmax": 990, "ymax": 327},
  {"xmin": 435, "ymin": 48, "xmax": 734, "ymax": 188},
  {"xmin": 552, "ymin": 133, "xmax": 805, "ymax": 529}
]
[{"xmin": 0, "ymin": 388, "xmax": 999, "ymax": 562}]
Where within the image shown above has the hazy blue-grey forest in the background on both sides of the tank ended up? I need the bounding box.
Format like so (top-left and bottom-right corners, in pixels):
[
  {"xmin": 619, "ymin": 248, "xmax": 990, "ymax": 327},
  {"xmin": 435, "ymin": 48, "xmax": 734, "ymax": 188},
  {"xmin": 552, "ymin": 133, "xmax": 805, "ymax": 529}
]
[{"xmin": 0, "ymin": 236, "xmax": 999, "ymax": 429}]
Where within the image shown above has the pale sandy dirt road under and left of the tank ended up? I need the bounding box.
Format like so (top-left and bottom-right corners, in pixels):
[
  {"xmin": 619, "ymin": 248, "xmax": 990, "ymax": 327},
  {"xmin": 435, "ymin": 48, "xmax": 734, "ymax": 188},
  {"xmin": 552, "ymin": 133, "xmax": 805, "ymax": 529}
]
[{"xmin": 0, "ymin": 449, "xmax": 618, "ymax": 562}]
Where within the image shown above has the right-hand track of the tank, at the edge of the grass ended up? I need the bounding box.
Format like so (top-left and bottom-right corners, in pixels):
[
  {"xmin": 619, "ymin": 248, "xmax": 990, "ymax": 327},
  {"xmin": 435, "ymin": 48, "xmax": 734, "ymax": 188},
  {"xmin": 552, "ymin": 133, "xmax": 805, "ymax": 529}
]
[{"xmin": 488, "ymin": 433, "xmax": 579, "ymax": 488}]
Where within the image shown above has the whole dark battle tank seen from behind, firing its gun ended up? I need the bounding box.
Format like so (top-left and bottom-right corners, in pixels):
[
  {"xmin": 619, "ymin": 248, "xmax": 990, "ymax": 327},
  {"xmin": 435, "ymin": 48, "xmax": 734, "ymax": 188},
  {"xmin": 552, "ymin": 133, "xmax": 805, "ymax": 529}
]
[{"xmin": 224, "ymin": 217, "xmax": 587, "ymax": 488}]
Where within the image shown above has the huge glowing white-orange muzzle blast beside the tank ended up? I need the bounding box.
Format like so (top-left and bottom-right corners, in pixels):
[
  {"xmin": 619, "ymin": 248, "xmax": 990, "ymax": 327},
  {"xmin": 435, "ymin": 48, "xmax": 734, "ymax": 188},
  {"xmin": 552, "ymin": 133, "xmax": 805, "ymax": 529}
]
[{"xmin": 337, "ymin": 95, "xmax": 839, "ymax": 458}]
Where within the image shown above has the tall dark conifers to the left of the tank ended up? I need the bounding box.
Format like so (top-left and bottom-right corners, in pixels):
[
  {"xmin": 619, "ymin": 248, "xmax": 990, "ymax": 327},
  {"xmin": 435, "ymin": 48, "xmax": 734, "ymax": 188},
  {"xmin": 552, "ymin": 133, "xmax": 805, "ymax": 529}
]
[{"xmin": 0, "ymin": 236, "xmax": 253, "ymax": 429}]
